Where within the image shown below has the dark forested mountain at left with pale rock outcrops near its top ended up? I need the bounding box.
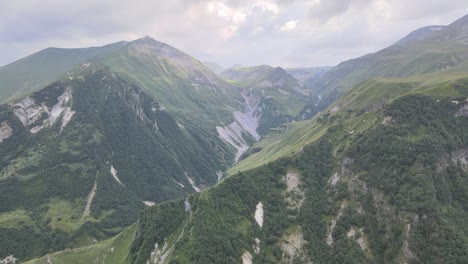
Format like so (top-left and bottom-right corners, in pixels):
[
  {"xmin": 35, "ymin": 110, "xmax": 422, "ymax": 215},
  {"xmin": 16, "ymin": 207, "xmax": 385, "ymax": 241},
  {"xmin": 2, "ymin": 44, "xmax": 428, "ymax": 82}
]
[{"xmin": 0, "ymin": 65, "xmax": 229, "ymax": 260}]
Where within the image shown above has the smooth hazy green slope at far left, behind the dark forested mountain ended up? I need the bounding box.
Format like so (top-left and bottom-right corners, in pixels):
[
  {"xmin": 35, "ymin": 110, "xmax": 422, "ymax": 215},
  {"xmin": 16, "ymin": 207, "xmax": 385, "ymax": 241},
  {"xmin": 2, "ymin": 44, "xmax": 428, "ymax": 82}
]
[{"xmin": 0, "ymin": 42, "xmax": 125, "ymax": 103}]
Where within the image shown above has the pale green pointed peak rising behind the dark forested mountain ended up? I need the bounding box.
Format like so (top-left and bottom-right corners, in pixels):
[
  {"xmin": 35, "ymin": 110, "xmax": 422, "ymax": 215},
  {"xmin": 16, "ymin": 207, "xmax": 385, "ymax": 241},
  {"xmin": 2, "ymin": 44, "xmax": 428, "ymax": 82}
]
[{"xmin": 92, "ymin": 37, "xmax": 244, "ymax": 128}]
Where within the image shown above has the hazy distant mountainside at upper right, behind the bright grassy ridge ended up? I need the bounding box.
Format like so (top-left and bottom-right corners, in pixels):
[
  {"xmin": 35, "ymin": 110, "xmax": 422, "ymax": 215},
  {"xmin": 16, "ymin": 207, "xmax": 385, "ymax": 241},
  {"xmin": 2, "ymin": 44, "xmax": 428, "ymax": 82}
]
[{"xmin": 309, "ymin": 13, "xmax": 468, "ymax": 109}]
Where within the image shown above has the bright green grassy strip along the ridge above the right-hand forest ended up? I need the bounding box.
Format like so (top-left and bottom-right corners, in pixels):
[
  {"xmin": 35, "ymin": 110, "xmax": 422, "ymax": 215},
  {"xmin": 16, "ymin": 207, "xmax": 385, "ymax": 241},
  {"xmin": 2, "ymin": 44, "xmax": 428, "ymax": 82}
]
[{"xmin": 228, "ymin": 69, "xmax": 468, "ymax": 175}]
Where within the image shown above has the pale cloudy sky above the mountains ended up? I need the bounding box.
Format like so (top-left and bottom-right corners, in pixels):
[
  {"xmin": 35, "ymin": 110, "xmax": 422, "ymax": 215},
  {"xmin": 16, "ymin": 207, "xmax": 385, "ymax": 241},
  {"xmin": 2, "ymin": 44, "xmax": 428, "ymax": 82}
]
[{"xmin": 0, "ymin": 0, "xmax": 468, "ymax": 67}]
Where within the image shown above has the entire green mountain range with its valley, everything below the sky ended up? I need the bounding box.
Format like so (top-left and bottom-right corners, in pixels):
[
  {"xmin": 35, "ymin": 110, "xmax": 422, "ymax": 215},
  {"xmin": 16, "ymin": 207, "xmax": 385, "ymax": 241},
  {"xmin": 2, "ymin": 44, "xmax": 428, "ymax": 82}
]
[{"xmin": 0, "ymin": 12, "xmax": 468, "ymax": 264}]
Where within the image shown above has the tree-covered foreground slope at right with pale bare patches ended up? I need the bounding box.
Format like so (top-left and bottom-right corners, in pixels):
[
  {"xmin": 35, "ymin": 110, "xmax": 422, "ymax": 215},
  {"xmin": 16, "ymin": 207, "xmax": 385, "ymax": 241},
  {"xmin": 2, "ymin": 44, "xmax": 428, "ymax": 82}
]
[{"xmin": 71, "ymin": 83, "xmax": 468, "ymax": 263}]
